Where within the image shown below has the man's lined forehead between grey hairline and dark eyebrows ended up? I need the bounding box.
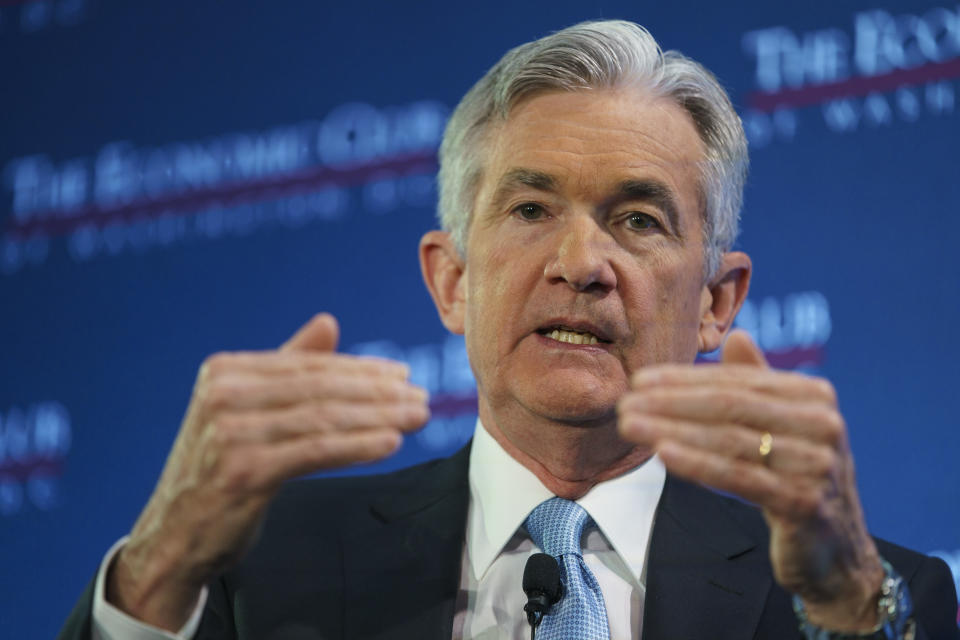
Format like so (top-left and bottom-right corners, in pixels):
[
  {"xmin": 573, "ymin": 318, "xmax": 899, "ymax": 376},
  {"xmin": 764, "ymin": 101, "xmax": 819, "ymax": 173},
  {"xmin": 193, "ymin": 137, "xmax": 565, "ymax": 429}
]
[{"xmin": 481, "ymin": 87, "xmax": 704, "ymax": 211}]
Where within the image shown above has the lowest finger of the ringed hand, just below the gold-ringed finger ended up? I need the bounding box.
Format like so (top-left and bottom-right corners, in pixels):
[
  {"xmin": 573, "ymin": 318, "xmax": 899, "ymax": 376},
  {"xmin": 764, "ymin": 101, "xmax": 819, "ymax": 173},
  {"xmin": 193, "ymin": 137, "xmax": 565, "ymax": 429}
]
[{"xmin": 657, "ymin": 441, "xmax": 825, "ymax": 518}]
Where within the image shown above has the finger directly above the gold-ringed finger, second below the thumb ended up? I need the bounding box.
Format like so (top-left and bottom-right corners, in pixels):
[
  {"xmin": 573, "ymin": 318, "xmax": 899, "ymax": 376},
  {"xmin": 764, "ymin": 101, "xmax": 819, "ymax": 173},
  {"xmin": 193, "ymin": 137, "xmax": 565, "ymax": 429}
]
[{"xmin": 618, "ymin": 387, "xmax": 846, "ymax": 445}]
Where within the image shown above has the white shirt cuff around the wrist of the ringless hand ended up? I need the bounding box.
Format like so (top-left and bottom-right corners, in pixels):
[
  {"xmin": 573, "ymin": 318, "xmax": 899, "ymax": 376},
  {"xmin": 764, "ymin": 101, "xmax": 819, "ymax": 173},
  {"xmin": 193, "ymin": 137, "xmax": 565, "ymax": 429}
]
[{"xmin": 91, "ymin": 536, "xmax": 207, "ymax": 640}]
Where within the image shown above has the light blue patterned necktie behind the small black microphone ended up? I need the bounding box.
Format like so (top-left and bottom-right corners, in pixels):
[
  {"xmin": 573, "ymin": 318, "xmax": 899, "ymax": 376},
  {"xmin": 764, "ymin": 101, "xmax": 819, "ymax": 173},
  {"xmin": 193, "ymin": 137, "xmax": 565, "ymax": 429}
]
[{"xmin": 526, "ymin": 498, "xmax": 610, "ymax": 640}]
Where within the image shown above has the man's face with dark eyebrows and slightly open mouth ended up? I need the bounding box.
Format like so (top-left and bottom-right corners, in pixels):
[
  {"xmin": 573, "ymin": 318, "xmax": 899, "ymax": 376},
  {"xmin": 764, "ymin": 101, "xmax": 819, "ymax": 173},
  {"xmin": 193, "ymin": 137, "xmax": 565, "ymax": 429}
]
[{"xmin": 461, "ymin": 89, "xmax": 709, "ymax": 422}]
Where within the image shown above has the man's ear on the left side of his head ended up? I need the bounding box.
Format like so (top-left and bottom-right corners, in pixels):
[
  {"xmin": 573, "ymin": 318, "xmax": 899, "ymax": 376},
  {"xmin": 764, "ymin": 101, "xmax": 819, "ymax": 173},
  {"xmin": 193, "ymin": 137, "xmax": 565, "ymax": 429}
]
[{"xmin": 420, "ymin": 231, "xmax": 466, "ymax": 334}]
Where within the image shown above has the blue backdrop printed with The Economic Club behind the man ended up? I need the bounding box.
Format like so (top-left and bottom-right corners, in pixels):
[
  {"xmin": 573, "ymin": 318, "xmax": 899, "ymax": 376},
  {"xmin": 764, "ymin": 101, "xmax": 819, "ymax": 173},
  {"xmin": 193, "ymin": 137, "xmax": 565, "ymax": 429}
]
[{"xmin": 0, "ymin": 0, "xmax": 960, "ymax": 638}]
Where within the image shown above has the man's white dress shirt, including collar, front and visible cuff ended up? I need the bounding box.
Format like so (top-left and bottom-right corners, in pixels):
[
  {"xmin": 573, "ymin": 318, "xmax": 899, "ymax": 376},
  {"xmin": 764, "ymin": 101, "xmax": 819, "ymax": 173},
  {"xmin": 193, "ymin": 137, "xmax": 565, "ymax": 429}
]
[{"xmin": 92, "ymin": 421, "xmax": 666, "ymax": 640}]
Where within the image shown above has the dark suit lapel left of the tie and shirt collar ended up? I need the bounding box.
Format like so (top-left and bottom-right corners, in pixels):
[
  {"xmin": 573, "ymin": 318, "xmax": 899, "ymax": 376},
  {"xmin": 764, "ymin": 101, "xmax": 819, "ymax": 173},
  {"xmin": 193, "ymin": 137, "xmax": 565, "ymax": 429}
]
[{"xmin": 341, "ymin": 446, "xmax": 469, "ymax": 640}]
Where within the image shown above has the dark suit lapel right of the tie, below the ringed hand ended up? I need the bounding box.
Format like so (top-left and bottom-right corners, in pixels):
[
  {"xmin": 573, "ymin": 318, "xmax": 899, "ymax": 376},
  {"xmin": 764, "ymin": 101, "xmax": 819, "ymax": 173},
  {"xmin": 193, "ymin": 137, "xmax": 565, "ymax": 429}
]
[{"xmin": 643, "ymin": 475, "xmax": 773, "ymax": 640}]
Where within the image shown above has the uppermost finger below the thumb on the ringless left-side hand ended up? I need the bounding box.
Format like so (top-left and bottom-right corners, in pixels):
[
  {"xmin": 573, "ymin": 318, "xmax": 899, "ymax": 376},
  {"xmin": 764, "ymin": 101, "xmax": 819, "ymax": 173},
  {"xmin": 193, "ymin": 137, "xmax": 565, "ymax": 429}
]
[{"xmin": 198, "ymin": 351, "xmax": 410, "ymax": 381}]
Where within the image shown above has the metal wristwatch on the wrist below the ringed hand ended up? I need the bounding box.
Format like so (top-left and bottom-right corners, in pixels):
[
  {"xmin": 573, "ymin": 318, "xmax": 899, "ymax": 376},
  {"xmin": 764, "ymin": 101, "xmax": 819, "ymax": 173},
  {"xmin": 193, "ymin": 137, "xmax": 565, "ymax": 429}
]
[{"xmin": 793, "ymin": 559, "xmax": 917, "ymax": 640}]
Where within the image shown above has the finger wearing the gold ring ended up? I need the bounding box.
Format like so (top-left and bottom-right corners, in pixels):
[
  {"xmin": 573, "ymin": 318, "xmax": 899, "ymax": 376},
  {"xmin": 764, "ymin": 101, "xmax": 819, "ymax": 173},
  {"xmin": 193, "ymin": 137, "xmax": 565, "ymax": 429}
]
[{"xmin": 620, "ymin": 415, "xmax": 836, "ymax": 477}]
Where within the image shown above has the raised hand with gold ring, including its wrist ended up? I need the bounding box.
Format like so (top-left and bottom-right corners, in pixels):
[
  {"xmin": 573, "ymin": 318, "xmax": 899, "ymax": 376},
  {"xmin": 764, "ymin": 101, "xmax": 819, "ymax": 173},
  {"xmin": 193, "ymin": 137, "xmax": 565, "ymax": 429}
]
[{"xmin": 618, "ymin": 332, "xmax": 883, "ymax": 630}]
